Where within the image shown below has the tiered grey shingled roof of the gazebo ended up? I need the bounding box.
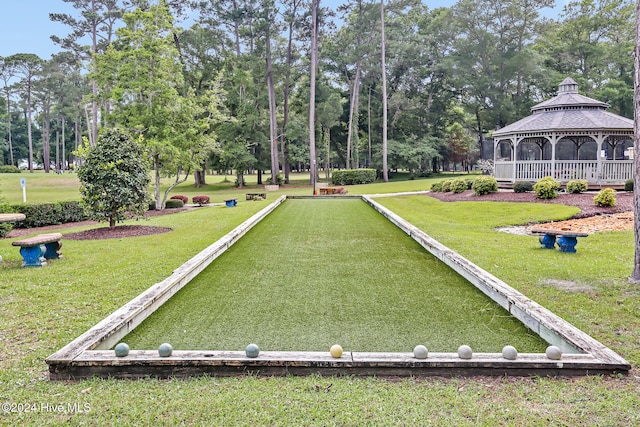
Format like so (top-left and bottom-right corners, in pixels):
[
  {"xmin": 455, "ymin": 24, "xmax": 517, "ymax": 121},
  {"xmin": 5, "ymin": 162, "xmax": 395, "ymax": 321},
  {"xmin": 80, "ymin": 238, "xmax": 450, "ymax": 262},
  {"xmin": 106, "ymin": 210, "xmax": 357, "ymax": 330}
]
[{"xmin": 493, "ymin": 77, "xmax": 633, "ymax": 139}]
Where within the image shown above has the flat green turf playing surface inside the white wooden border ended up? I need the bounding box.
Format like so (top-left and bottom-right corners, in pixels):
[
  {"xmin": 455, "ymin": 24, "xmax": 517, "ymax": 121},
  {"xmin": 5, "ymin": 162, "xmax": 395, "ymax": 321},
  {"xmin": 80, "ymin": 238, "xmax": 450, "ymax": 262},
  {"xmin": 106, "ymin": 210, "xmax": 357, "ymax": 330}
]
[{"xmin": 124, "ymin": 199, "xmax": 546, "ymax": 353}]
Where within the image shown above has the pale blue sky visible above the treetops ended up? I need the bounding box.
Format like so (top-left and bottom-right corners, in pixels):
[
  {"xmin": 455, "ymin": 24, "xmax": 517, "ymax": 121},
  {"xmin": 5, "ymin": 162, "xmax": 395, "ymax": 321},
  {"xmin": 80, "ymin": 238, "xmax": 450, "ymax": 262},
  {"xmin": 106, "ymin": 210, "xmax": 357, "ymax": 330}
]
[{"xmin": 0, "ymin": 0, "xmax": 564, "ymax": 59}]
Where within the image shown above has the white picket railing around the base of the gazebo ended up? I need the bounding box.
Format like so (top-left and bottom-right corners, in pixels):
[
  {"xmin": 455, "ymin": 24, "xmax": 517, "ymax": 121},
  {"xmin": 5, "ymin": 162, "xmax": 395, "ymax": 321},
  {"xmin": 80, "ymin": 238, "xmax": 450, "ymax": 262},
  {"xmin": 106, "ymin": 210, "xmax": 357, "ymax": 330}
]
[{"xmin": 494, "ymin": 160, "xmax": 633, "ymax": 184}]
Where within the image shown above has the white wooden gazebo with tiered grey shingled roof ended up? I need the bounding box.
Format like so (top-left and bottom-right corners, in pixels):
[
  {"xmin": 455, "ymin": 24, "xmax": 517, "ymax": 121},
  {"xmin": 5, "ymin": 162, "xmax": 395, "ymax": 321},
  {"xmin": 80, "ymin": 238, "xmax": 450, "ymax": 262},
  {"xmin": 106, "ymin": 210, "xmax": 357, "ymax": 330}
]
[{"xmin": 493, "ymin": 77, "xmax": 633, "ymax": 186}]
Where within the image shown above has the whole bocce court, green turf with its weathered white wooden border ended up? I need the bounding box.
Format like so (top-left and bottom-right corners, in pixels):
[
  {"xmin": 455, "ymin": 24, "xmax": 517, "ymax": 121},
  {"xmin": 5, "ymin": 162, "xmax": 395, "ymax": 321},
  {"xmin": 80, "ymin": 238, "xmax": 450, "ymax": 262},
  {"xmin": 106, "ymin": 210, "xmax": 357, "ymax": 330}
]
[{"xmin": 47, "ymin": 196, "xmax": 630, "ymax": 379}]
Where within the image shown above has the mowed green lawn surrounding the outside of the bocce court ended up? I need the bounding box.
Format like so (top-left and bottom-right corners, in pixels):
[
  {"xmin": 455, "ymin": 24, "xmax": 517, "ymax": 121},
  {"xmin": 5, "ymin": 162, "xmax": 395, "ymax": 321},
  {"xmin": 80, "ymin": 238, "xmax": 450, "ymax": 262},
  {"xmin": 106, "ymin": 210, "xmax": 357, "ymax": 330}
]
[{"xmin": 0, "ymin": 174, "xmax": 640, "ymax": 426}]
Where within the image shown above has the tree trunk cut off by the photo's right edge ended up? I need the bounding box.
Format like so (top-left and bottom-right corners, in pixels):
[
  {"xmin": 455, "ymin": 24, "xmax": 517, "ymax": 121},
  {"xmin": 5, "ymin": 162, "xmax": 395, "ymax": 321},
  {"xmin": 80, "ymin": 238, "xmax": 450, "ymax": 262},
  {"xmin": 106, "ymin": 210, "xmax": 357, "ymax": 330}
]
[{"xmin": 629, "ymin": 0, "xmax": 640, "ymax": 284}]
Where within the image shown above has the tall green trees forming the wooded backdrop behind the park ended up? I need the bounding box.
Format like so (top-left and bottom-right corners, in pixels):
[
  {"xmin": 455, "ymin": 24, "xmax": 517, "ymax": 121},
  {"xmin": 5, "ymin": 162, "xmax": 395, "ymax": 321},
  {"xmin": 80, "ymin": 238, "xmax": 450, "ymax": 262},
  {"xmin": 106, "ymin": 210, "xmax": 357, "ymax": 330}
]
[{"xmin": 0, "ymin": 0, "xmax": 634, "ymax": 178}]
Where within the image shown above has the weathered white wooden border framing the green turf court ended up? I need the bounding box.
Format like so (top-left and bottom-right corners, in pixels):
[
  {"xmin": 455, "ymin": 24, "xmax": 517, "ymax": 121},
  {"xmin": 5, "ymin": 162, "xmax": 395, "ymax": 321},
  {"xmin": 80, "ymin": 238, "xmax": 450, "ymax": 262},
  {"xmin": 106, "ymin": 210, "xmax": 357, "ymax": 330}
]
[{"xmin": 46, "ymin": 192, "xmax": 631, "ymax": 380}]
